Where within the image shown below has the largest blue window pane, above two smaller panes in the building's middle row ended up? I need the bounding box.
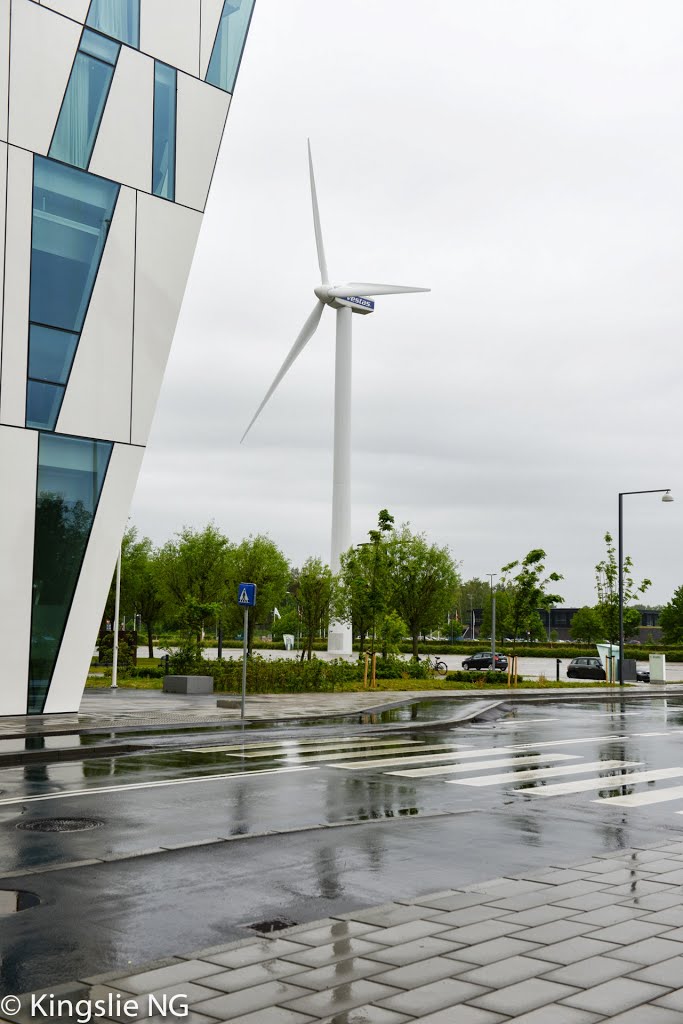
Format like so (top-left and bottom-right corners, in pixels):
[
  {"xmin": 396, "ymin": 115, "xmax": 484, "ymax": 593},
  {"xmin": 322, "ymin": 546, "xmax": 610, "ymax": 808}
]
[{"xmin": 30, "ymin": 157, "xmax": 120, "ymax": 332}]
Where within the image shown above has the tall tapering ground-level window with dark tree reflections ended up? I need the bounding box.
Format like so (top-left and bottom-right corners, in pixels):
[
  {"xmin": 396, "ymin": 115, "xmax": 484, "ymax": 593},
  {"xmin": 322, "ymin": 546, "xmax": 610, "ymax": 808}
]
[{"xmin": 28, "ymin": 434, "xmax": 113, "ymax": 715}]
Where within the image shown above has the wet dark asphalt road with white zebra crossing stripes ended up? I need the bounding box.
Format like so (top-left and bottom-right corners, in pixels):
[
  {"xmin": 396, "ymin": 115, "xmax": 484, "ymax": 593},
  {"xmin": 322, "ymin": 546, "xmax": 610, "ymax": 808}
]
[{"xmin": 0, "ymin": 698, "xmax": 683, "ymax": 993}]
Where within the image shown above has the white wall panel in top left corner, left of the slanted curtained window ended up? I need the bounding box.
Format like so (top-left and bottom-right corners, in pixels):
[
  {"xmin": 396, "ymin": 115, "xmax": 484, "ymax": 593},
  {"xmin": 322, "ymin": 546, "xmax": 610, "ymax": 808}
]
[{"xmin": 8, "ymin": 0, "xmax": 81, "ymax": 156}]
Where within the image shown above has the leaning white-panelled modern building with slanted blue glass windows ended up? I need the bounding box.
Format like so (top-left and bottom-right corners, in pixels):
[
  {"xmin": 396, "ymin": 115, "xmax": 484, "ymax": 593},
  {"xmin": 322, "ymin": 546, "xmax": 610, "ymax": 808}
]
[{"xmin": 0, "ymin": 0, "xmax": 254, "ymax": 715}]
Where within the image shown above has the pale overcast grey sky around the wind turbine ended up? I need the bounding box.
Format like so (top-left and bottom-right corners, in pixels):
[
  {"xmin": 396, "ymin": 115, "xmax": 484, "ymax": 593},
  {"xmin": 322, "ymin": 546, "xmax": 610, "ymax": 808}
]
[{"xmin": 132, "ymin": 0, "xmax": 683, "ymax": 604}]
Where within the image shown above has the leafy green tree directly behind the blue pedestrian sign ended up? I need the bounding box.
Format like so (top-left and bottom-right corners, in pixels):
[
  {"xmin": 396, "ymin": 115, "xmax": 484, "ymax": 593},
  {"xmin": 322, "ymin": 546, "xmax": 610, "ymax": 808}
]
[{"xmin": 226, "ymin": 534, "xmax": 291, "ymax": 655}]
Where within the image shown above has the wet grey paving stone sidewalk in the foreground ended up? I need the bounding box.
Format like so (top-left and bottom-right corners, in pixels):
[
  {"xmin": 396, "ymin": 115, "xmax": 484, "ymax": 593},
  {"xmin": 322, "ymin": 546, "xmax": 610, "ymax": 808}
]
[{"xmin": 11, "ymin": 842, "xmax": 683, "ymax": 1024}]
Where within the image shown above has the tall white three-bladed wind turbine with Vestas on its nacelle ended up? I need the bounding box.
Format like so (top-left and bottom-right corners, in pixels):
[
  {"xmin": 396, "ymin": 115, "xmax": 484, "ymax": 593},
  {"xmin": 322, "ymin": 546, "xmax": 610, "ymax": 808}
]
[{"xmin": 240, "ymin": 141, "xmax": 430, "ymax": 654}]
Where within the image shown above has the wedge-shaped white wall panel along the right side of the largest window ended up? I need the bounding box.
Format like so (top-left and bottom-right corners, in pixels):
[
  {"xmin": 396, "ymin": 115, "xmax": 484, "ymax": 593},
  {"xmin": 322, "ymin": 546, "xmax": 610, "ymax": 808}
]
[{"xmin": 56, "ymin": 188, "xmax": 135, "ymax": 441}]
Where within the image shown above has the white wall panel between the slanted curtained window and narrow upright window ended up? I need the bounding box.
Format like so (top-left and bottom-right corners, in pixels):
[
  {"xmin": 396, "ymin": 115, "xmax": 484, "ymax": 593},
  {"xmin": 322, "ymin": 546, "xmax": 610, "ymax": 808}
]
[{"xmin": 88, "ymin": 46, "xmax": 155, "ymax": 191}]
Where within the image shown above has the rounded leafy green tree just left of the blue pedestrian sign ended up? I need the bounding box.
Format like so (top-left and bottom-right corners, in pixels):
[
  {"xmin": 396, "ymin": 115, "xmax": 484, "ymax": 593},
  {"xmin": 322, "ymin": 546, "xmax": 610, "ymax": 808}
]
[{"xmin": 157, "ymin": 522, "xmax": 232, "ymax": 644}]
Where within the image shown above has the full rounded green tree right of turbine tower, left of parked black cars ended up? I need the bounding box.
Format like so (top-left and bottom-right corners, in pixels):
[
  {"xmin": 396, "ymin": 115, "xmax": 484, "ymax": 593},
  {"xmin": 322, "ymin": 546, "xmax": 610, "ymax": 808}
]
[{"xmin": 387, "ymin": 524, "xmax": 460, "ymax": 658}]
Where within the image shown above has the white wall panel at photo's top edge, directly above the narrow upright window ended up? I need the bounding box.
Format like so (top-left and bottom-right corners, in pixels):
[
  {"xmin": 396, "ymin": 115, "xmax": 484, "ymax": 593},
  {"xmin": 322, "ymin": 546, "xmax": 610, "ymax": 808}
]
[{"xmin": 140, "ymin": 0, "xmax": 200, "ymax": 76}]
